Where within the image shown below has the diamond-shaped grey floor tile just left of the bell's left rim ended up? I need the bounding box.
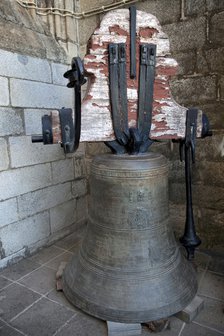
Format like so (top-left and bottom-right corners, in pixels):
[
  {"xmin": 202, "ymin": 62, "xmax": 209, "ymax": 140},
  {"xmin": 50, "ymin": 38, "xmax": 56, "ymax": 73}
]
[{"xmin": 19, "ymin": 266, "xmax": 56, "ymax": 294}]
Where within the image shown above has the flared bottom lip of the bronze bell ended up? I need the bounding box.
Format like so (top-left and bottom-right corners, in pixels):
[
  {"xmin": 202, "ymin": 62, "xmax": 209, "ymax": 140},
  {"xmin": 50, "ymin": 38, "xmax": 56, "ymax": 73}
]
[{"xmin": 62, "ymin": 252, "xmax": 198, "ymax": 323}]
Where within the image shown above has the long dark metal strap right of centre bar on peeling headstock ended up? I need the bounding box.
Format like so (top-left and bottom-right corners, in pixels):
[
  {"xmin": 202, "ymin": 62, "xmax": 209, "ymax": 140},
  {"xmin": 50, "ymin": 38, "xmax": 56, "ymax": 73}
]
[{"xmin": 138, "ymin": 44, "xmax": 156, "ymax": 142}]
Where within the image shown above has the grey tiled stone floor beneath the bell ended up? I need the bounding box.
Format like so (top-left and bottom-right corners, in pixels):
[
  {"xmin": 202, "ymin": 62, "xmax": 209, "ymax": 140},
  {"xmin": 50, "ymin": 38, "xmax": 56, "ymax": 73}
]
[{"xmin": 0, "ymin": 231, "xmax": 224, "ymax": 336}]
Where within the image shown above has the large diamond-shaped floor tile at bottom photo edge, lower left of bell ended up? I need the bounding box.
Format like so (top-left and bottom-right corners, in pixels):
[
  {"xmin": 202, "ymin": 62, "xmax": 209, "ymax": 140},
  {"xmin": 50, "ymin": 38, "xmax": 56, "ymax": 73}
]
[{"xmin": 12, "ymin": 298, "xmax": 75, "ymax": 336}]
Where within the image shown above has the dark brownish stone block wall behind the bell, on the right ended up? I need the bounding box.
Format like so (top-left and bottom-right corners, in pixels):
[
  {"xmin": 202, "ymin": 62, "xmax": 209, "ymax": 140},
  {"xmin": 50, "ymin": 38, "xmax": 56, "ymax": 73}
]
[{"xmin": 79, "ymin": 0, "xmax": 224, "ymax": 250}]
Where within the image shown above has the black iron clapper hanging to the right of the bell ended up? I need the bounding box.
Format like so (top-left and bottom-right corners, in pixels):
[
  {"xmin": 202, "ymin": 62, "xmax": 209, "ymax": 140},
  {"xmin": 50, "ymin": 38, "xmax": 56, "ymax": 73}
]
[{"xmin": 180, "ymin": 108, "xmax": 201, "ymax": 260}]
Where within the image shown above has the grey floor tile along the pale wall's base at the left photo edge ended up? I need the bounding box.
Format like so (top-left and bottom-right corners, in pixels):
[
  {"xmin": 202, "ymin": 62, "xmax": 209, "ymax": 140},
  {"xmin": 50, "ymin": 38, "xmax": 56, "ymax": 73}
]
[{"xmin": 1, "ymin": 259, "xmax": 40, "ymax": 280}]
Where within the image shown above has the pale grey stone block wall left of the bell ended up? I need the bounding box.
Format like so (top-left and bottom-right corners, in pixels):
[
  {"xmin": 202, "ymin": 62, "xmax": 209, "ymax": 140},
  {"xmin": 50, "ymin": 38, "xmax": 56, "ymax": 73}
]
[{"xmin": 0, "ymin": 0, "xmax": 87, "ymax": 268}]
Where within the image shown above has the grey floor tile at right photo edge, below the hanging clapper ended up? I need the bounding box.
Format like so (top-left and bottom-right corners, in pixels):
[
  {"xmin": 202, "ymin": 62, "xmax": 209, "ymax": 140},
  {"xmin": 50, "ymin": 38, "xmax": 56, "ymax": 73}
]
[{"xmin": 199, "ymin": 272, "xmax": 224, "ymax": 301}]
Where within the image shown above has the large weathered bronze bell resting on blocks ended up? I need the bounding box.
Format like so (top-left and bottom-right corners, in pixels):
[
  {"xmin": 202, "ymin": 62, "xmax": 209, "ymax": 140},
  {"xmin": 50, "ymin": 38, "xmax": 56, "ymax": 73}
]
[{"xmin": 63, "ymin": 153, "xmax": 197, "ymax": 323}]
